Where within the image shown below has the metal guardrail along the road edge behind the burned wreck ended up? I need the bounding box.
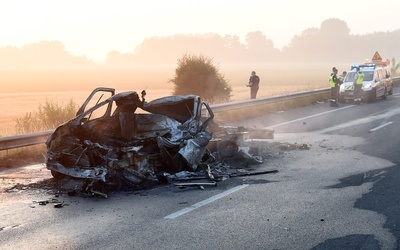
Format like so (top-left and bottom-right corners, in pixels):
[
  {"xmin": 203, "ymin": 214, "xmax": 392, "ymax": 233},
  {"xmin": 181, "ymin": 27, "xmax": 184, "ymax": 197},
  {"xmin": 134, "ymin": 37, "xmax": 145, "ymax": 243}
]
[{"xmin": 7, "ymin": 77, "xmax": 400, "ymax": 151}]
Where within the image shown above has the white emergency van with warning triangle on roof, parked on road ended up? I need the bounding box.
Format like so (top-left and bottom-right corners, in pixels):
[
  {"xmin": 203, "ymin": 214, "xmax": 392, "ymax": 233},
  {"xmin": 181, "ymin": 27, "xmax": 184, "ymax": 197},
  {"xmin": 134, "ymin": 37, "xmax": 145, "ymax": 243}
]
[{"xmin": 339, "ymin": 63, "xmax": 393, "ymax": 103}]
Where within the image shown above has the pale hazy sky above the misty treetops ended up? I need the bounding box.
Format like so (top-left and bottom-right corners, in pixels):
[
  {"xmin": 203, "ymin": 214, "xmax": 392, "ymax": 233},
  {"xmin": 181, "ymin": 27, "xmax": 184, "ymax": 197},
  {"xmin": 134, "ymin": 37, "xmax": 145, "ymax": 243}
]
[{"xmin": 0, "ymin": 0, "xmax": 400, "ymax": 62}]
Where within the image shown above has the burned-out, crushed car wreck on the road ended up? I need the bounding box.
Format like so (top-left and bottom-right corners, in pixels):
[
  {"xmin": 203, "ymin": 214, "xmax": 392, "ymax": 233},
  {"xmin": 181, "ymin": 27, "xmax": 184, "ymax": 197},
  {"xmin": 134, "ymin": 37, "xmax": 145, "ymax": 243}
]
[{"xmin": 46, "ymin": 87, "xmax": 273, "ymax": 193}]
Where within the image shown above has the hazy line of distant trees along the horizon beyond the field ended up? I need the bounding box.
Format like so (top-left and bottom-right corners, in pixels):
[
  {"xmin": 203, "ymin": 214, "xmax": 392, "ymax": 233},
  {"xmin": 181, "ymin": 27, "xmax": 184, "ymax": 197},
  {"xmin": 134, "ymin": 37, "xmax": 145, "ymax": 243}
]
[{"xmin": 0, "ymin": 18, "xmax": 400, "ymax": 69}]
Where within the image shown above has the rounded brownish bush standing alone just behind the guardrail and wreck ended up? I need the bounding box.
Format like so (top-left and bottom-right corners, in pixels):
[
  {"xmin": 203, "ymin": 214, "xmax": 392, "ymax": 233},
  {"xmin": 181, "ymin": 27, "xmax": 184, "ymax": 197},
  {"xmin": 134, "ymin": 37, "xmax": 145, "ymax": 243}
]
[{"xmin": 169, "ymin": 54, "xmax": 232, "ymax": 103}]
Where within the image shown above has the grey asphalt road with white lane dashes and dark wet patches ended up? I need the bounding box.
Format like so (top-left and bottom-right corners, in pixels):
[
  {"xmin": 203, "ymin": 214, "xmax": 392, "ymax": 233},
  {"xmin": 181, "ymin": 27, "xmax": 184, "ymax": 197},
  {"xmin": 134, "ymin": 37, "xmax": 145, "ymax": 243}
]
[{"xmin": 0, "ymin": 88, "xmax": 400, "ymax": 249}]
